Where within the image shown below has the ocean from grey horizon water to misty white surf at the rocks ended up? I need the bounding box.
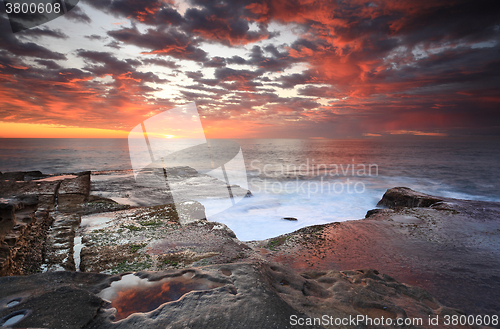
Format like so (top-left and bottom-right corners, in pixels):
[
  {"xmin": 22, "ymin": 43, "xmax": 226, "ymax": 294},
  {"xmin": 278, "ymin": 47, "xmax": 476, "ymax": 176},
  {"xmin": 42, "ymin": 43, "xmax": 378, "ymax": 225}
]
[{"xmin": 0, "ymin": 137, "xmax": 500, "ymax": 241}]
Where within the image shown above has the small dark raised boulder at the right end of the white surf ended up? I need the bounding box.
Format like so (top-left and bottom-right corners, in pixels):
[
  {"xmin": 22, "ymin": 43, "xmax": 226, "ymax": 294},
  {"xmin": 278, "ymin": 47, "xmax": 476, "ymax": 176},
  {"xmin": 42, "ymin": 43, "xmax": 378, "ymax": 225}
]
[{"xmin": 377, "ymin": 187, "xmax": 443, "ymax": 208}]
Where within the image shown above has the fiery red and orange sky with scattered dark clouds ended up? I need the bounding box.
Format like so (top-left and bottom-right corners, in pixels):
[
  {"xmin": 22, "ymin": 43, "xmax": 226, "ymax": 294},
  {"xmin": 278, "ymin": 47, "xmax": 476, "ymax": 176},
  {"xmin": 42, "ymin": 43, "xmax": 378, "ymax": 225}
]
[{"xmin": 0, "ymin": 0, "xmax": 500, "ymax": 138}]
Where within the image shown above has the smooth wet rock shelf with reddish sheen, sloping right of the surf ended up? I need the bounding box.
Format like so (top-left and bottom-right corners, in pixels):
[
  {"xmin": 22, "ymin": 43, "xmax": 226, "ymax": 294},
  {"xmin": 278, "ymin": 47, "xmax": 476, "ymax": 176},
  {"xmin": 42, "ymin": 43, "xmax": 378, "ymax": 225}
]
[{"xmin": 256, "ymin": 188, "xmax": 500, "ymax": 315}]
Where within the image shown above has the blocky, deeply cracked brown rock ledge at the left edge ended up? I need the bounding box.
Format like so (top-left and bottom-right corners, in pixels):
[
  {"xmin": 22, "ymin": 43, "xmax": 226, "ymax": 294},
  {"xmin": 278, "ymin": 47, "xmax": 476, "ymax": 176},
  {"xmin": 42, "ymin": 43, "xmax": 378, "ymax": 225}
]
[{"xmin": 0, "ymin": 172, "xmax": 90, "ymax": 275}]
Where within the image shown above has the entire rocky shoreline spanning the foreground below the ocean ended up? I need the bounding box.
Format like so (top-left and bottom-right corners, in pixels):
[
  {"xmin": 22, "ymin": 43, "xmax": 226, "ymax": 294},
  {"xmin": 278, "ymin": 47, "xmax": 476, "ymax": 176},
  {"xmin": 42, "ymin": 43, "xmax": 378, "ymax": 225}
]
[{"xmin": 0, "ymin": 172, "xmax": 500, "ymax": 328}]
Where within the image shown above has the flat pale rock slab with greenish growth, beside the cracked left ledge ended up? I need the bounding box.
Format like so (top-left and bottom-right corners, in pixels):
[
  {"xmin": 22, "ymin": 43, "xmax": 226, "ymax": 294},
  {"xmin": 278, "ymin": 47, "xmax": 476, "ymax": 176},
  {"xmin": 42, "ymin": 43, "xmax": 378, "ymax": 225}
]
[{"xmin": 79, "ymin": 202, "xmax": 255, "ymax": 273}]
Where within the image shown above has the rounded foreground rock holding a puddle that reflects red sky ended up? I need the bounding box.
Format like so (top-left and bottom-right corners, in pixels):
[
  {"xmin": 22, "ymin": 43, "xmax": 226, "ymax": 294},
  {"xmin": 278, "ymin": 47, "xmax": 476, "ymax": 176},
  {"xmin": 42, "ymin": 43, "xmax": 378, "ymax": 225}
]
[{"xmin": 0, "ymin": 261, "xmax": 472, "ymax": 329}]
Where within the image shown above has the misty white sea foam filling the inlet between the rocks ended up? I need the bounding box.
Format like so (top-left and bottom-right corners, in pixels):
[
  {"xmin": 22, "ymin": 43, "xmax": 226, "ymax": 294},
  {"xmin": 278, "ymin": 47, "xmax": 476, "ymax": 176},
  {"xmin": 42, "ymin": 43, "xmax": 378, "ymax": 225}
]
[{"xmin": 208, "ymin": 178, "xmax": 380, "ymax": 241}]
